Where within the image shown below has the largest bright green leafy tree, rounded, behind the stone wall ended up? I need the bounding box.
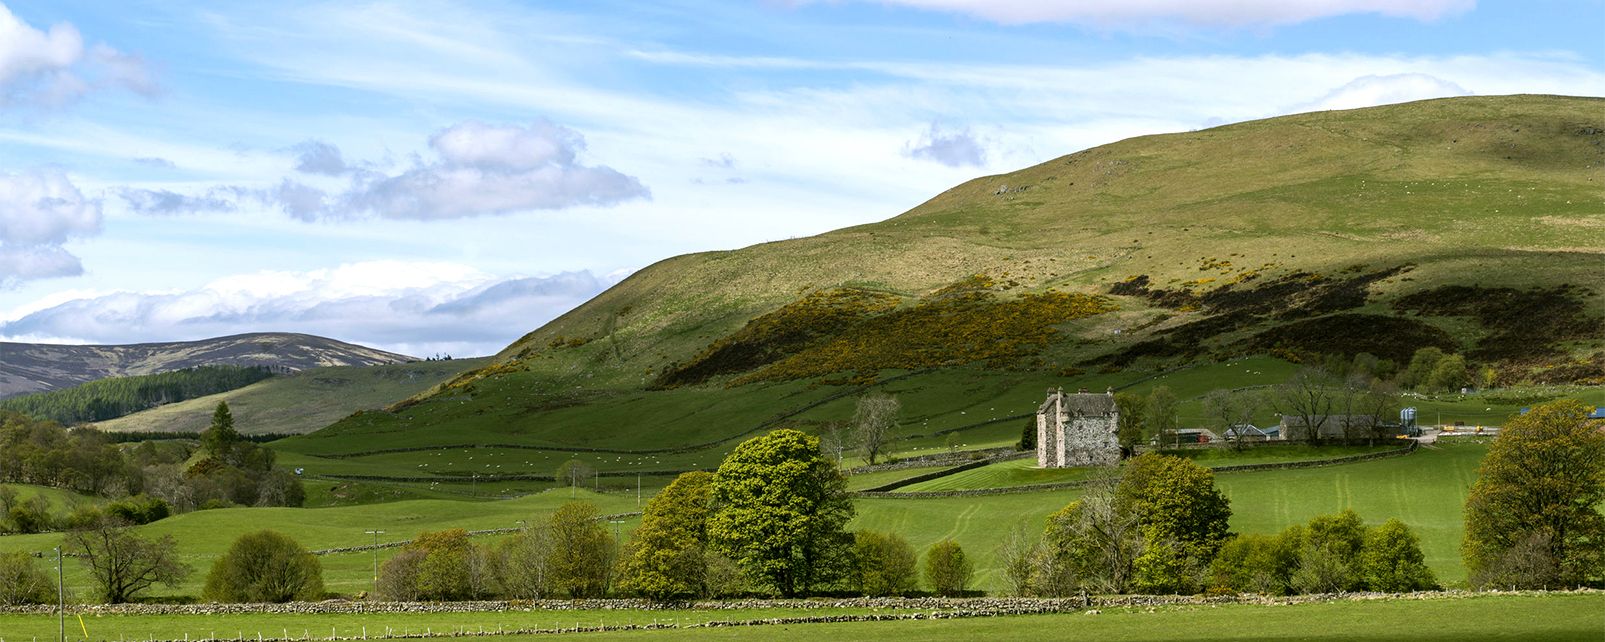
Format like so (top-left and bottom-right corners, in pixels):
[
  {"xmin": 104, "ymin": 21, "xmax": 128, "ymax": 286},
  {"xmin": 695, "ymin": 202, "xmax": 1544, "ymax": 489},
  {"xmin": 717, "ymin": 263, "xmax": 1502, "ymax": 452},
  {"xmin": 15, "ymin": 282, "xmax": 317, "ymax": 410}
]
[{"xmin": 708, "ymin": 430, "xmax": 854, "ymax": 597}]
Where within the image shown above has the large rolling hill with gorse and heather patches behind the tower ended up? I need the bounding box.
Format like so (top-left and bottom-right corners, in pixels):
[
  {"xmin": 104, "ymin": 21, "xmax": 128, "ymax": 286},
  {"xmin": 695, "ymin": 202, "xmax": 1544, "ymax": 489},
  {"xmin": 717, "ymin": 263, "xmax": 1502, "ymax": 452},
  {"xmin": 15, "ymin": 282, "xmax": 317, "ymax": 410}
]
[{"xmin": 276, "ymin": 96, "xmax": 1605, "ymax": 475}]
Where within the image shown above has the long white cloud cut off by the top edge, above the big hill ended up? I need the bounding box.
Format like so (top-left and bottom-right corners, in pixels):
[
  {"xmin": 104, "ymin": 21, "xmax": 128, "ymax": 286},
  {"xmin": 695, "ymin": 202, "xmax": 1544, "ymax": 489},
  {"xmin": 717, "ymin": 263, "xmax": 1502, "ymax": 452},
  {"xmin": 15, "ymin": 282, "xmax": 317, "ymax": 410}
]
[{"xmin": 828, "ymin": 0, "xmax": 1477, "ymax": 27}]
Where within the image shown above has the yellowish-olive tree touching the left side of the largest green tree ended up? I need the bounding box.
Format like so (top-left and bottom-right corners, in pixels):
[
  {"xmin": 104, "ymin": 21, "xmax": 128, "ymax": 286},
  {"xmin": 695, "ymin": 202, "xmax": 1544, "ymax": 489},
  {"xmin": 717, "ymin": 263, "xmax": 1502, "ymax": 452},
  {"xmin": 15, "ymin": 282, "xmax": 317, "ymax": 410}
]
[{"xmin": 623, "ymin": 470, "xmax": 713, "ymax": 600}]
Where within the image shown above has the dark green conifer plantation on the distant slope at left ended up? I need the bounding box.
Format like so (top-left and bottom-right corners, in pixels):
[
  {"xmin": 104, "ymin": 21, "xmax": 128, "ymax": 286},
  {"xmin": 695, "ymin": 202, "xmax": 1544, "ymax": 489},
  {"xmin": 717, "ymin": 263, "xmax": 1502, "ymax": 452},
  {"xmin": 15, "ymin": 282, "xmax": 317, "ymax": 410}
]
[{"xmin": 0, "ymin": 366, "xmax": 273, "ymax": 425}]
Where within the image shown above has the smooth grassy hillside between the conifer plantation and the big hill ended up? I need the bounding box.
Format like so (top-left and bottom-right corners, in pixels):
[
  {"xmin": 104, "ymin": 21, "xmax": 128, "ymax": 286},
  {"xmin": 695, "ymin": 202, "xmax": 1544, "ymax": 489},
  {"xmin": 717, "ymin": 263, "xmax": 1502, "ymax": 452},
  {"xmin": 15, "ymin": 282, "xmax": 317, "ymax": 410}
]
[{"xmin": 95, "ymin": 358, "xmax": 488, "ymax": 435}]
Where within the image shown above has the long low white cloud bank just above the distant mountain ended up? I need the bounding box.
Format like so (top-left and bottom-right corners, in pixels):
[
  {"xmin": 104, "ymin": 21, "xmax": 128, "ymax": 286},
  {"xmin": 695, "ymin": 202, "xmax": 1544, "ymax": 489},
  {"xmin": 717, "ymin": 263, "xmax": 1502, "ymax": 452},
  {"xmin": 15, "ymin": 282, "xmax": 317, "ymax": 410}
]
[{"xmin": 0, "ymin": 260, "xmax": 624, "ymax": 356}]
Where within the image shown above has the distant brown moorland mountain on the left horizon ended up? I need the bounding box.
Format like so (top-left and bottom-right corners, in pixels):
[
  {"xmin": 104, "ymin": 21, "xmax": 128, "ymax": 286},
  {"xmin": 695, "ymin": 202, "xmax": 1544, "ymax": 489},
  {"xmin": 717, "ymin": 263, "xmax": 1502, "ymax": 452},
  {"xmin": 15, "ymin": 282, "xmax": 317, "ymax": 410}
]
[{"xmin": 0, "ymin": 332, "xmax": 416, "ymax": 398}]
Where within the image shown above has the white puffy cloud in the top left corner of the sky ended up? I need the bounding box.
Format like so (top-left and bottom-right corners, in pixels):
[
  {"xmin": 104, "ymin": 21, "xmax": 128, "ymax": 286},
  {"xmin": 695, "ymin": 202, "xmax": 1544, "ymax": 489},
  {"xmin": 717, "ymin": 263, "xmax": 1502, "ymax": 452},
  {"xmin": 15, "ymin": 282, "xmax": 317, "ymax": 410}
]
[{"xmin": 0, "ymin": 5, "xmax": 156, "ymax": 106}]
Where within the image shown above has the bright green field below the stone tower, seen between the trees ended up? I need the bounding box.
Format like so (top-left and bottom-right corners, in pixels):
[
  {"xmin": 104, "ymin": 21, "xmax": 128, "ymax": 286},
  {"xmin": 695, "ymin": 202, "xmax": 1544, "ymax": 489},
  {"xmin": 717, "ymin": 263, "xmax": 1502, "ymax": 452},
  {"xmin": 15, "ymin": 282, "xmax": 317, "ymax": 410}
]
[{"xmin": 852, "ymin": 440, "xmax": 1488, "ymax": 591}]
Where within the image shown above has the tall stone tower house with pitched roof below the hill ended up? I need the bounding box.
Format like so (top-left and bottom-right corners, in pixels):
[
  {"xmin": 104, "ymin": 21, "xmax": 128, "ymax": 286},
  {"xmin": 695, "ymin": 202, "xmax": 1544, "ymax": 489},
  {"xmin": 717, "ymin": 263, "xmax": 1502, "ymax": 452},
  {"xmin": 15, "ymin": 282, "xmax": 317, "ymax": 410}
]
[{"xmin": 1037, "ymin": 388, "xmax": 1120, "ymax": 469}]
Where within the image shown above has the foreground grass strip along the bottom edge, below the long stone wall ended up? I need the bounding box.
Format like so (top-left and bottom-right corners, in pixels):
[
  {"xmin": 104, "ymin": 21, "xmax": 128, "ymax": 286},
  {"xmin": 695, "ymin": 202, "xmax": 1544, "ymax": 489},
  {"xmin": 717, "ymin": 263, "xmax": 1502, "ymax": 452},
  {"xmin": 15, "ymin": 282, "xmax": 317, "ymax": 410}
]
[{"xmin": 0, "ymin": 592, "xmax": 1605, "ymax": 642}]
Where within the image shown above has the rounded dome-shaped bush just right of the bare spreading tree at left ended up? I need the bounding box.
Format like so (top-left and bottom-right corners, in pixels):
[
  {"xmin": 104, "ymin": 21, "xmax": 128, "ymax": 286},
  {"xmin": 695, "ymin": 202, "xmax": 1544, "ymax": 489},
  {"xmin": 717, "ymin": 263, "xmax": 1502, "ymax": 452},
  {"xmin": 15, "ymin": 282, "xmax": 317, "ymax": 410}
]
[{"xmin": 202, "ymin": 531, "xmax": 323, "ymax": 603}]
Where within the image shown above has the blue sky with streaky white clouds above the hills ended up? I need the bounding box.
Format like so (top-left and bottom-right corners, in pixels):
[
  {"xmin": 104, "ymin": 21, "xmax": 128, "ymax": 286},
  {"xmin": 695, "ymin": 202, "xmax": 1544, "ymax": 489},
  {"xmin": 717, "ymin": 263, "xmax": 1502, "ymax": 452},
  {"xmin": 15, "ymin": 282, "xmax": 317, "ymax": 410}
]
[{"xmin": 0, "ymin": 0, "xmax": 1605, "ymax": 356}]
